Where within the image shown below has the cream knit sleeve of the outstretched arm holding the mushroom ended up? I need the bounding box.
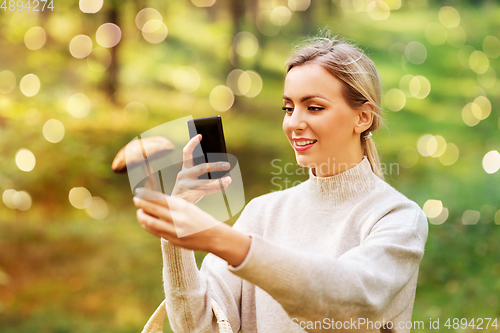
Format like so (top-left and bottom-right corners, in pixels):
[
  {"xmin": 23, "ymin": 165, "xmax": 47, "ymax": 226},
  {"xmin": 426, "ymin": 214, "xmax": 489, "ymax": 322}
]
[{"xmin": 229, "ymin": 202, "xmax": 428, "ymax": 321}]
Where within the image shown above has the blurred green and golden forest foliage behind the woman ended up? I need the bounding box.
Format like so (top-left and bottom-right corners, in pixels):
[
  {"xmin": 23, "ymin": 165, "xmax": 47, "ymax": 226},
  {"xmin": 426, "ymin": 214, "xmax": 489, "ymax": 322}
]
[{"xmin": 0, "ymin": 0, "xmax": 500, "ymax": 333}]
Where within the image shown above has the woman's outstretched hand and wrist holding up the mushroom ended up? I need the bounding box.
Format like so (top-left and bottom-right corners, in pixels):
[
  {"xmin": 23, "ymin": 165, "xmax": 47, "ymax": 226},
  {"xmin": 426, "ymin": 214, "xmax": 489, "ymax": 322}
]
[{"xmin": 134, "ymin": 189, "xmax": 250, "ymax": 266}]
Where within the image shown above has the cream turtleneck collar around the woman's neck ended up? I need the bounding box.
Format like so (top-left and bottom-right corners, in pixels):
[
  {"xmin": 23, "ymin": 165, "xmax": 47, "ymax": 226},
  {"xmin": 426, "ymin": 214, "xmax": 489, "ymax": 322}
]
[{"xmin": 305, "ymin": 156, "xmax": 381, "ymax": 208}]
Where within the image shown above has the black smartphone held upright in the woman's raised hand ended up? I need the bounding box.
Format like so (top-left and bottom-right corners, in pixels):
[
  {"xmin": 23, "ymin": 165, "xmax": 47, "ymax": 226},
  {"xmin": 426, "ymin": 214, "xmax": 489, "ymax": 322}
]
[{"xmin": 188, "ymin": 116, "xmax": 229, "ymax": 179}]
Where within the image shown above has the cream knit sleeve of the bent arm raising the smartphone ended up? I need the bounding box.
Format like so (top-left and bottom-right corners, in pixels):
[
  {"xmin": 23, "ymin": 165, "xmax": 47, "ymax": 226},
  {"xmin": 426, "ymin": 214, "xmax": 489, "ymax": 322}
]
[{"xmin": 161, "ymin": 198, "xmax": 260, "ymax": 333}]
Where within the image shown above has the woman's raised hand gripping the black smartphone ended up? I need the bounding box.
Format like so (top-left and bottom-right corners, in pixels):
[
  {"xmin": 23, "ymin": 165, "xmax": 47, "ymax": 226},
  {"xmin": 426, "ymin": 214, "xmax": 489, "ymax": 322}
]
[{"xmin": 172, "ymin": 134, "xmax": 231, "ymax": 203}]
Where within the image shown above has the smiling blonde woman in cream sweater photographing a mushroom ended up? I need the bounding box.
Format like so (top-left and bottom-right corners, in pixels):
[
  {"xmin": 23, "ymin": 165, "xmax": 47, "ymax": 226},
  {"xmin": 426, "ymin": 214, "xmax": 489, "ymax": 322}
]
[{"xmin": 134, "ymin": 37, "xmax": 428, "ymax": 333}]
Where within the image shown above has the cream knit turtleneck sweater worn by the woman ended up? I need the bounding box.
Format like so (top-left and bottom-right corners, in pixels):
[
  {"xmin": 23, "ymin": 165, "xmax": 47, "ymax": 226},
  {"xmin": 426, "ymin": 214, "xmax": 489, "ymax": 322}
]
[{"xmin": 162, "ymin": 157, "xmax": 428, "ymax": 333}]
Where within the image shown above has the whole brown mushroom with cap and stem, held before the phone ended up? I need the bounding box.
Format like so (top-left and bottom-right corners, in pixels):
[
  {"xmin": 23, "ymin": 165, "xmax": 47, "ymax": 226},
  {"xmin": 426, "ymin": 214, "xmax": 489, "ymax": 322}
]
[{"xmin": 111, "ymin": 136, "xmax": 175, "ymax": 190}]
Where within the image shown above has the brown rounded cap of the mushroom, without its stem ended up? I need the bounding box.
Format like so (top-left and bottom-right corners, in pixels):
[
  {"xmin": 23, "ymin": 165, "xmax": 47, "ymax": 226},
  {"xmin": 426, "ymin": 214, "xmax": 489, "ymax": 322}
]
[{"xmin": 111, "ymin": 136, "xmax": 175, "ymax": 173}]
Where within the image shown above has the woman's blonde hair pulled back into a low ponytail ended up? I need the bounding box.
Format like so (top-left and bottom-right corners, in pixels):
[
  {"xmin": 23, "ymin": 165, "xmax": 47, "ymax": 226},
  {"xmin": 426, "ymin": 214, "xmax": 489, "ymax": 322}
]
[{"xmin": 285, "ymin": 31, "xmax": 384, "ymax": 179}]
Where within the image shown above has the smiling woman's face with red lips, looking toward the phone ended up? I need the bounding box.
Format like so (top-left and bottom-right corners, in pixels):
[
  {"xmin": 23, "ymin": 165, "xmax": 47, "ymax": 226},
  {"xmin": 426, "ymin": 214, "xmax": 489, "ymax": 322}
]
[{"xmin": 283, "ymin": 63, "xmax": 363, "ymax": 177}]
